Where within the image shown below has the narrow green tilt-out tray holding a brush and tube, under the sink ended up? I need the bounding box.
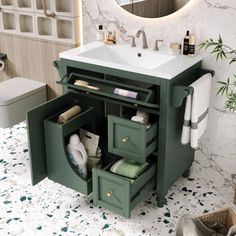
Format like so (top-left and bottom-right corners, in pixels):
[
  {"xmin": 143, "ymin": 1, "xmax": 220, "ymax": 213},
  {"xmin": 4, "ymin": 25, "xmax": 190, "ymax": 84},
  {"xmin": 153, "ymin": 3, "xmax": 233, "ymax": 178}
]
[{"xmin": 57, "ymin": 73, "xmax": 159, "ymax": 108}]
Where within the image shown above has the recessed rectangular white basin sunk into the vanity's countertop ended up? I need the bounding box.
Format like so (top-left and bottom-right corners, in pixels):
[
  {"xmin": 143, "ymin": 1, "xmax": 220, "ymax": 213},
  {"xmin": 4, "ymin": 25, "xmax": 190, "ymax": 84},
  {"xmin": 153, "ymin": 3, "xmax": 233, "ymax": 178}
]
[{"xmin": 78, "ymin": 44, "xmax": 175, "ymax": 70}]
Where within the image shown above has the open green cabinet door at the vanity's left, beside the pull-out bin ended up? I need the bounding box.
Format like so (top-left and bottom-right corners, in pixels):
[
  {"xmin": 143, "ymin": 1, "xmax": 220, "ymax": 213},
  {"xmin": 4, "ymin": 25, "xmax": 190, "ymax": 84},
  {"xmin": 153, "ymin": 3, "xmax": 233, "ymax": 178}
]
[{"xmin": 27, "ymin": 93, "xmax": 76, "ymax": 185}]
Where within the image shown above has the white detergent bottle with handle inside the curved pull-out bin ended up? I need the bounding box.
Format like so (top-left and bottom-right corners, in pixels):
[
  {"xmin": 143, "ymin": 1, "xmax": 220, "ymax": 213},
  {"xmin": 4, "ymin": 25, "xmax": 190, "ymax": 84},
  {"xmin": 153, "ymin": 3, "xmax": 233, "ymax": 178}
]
[{"xmin": 67, "ymin": 134, "xmax": 88, "ymax": 179}]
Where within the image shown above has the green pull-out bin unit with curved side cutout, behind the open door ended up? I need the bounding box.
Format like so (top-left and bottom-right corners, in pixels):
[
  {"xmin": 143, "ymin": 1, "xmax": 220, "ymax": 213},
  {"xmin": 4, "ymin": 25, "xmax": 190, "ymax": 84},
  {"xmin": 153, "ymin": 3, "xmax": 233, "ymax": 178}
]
[{"xmin": 44, "ymin": 107, "xmax": 94, "ymax": 195}]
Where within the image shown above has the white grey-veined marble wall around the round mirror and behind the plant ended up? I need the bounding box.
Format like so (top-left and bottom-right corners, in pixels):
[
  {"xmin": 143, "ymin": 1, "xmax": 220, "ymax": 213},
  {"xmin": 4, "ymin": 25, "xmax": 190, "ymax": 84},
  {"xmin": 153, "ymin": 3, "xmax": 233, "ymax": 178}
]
[{"xmin": 83, "ymin": 0, "xmax": 236, "ymax": 164}]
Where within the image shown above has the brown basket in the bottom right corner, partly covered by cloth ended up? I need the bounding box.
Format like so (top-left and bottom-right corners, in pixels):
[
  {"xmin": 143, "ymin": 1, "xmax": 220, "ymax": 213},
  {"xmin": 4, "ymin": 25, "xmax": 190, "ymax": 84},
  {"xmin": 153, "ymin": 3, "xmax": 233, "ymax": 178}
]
[{"xmin": 199, "ymin": 208, "xmax": 236, "ymax": 230}]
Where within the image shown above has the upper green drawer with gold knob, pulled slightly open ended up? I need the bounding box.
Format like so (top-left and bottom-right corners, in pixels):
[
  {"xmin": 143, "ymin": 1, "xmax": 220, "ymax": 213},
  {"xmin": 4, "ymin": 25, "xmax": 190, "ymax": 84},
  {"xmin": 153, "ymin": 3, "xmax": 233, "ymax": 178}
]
[{"xmin": 108, "ymin": 115, "xmax": 157, "ymax": 163}]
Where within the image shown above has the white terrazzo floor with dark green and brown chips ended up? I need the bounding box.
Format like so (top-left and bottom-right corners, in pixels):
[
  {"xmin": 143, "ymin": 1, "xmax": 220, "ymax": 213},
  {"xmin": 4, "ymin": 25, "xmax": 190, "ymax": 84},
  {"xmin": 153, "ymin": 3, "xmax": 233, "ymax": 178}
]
[{"xmin": 0, "ymin": 122, "xmax": 236, "ymax": 236}]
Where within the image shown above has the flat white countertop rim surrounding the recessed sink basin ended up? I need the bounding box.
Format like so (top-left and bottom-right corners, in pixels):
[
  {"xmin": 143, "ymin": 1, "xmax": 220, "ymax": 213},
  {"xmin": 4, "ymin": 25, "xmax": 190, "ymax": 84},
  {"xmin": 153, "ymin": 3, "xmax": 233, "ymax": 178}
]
[{"xmin": 59, "ymin": 41, "xmax": 202, "ymax": 79}]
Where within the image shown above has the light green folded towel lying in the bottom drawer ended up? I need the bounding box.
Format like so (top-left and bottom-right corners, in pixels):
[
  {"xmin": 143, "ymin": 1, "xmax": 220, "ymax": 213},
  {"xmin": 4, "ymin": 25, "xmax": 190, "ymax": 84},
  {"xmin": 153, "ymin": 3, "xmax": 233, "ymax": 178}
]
[{"xmin": 110, "ymin": 159, "xmax": 148, "ymax": 179}]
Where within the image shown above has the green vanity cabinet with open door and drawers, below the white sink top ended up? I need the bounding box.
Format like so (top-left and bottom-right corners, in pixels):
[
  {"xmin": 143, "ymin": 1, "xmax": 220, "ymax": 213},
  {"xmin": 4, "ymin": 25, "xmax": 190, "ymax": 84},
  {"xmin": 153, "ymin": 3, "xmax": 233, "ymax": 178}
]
[{"xmin": 27, "ymin": 53, "xmax": 213, "ymax": 217}]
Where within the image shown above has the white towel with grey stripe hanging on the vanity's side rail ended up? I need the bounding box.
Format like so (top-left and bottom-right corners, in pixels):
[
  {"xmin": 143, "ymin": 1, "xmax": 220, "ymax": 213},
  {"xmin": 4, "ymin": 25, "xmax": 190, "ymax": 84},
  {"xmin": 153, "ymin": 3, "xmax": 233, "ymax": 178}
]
[{"xmin": 181, "ymin": 73, "xmax": 212, "ymax": 149}]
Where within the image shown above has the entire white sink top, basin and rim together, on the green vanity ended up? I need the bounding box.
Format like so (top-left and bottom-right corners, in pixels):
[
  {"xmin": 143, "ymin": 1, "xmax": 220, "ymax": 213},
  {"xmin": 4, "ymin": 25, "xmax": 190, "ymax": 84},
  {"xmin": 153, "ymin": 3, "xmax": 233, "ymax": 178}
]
[{"xmin": 59, "ymin": 41, "xmax": 202, "ymax": 79}]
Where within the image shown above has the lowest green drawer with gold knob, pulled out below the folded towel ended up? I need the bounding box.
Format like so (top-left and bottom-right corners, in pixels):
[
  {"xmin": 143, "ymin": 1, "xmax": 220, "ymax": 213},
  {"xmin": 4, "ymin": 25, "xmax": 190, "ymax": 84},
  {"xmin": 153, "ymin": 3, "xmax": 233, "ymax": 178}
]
[{"xmin": 93, "ymin": 164, "xmax": 156, "ymax": 218}]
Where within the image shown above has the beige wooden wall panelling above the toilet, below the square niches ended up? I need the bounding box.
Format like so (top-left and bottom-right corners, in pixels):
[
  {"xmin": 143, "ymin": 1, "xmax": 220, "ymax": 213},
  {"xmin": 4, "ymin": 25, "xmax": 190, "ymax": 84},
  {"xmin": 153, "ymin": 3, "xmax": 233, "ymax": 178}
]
[{"xmin": 0, "ymin": 33, "xmax": 74, "ymax": 99}]
